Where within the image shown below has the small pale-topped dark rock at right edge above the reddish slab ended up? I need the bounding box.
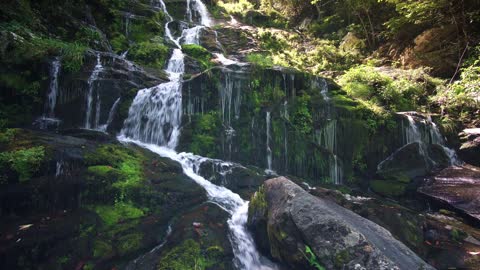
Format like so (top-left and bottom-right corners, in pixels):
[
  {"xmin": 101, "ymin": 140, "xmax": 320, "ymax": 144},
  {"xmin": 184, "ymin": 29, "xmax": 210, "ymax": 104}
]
[{"xmin": 458, "ymin": 128, "xmax": 480, "ymax": 166}]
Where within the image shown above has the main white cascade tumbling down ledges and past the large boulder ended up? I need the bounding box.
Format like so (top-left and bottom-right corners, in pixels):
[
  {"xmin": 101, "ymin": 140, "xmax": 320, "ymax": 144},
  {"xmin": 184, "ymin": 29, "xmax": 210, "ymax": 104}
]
[{"xmin": 118, "ymin": 0, "xmax": 276, "ymax": 270}]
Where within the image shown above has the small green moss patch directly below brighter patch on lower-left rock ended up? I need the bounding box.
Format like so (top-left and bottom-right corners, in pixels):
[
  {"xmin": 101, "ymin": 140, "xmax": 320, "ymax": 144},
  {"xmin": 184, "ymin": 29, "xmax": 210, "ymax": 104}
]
[{"xmin": 93, "ymin": 202, "xmax": 145, "ymax": 226}]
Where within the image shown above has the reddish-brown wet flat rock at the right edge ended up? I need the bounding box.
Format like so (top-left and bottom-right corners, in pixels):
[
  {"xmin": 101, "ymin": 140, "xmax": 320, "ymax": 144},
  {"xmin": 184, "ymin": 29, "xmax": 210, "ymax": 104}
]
[{"xmin": 418, "ymin": 165, "xmax": 480, "ymax": 224}]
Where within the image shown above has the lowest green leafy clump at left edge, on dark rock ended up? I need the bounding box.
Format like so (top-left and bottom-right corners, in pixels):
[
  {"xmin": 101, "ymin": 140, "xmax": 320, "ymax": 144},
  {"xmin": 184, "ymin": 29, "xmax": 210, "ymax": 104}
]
[{"xmin": 0, "ymin": 146, "xmax": 45, "ymax": 182}]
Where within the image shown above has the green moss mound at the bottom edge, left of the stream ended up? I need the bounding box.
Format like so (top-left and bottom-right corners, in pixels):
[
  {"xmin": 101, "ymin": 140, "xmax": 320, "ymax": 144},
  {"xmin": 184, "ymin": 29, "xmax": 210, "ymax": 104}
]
[{"xmin": 158, "ymin": 239, "xmax": 220, "ymax": 270}]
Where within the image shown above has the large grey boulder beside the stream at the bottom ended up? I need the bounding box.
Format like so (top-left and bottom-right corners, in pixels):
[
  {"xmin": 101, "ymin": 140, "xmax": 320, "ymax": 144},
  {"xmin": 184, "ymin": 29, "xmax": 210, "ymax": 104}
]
[{"xmin": 248, "ymin": 177, "xmax": 433, "ymax": 269}]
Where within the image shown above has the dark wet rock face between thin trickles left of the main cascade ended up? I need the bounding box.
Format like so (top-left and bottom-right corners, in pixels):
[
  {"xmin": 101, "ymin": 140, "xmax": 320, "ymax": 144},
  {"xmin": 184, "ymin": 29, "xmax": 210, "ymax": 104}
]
[{"xmin": 55, "ymin": 53, "xmax": 166, "ymax": 133}]
